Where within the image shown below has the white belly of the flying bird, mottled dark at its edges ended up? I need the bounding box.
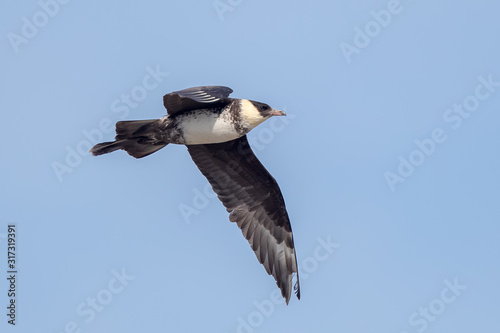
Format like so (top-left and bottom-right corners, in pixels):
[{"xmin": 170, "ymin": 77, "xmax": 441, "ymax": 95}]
[{"xmin": 179, "ymin": 112, "xmax": 244, "ymax": 145}]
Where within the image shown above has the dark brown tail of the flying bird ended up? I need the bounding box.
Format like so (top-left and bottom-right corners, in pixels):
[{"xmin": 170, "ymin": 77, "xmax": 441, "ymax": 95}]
[{"xmin": 89, "ymin": 119, "xmax": 168, "ymax": 158}]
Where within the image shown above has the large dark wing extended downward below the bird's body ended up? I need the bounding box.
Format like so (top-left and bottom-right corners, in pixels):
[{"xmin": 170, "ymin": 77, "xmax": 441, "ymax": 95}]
[{"xmin": 187, "ymin": 136, "xmax": 300, "ymax": 304}]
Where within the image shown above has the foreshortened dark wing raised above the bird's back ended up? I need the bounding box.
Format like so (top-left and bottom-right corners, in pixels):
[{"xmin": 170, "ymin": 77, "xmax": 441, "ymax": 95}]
[{"xmin": 163, "ymin": 86, "xmax": 233, "ymax": 115}]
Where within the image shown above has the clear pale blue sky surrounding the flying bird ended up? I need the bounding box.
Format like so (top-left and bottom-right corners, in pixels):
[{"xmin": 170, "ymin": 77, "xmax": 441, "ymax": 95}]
[{"xmin": 0, "ymin": 0, "xmax": 500, "ymax": 333}]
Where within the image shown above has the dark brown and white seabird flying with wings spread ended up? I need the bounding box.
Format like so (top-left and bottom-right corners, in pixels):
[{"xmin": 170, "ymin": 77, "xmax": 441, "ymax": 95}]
[{"xmin": 90, "ymin": 86, "xmax": 300, "ymax": 304}]
